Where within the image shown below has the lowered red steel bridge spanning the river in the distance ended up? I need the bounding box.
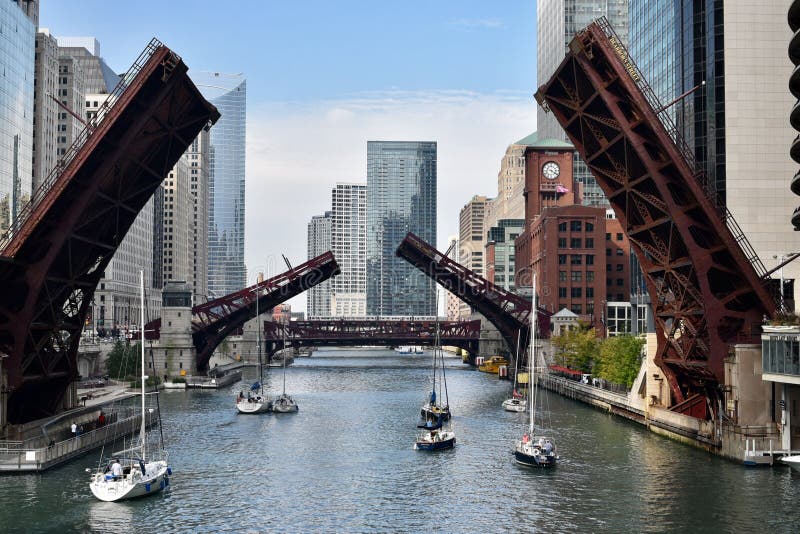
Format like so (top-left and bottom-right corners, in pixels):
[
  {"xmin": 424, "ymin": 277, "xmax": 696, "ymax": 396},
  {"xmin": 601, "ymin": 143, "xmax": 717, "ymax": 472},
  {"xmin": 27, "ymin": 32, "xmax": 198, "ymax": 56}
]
[{"xmin": 264, "ymin": 319, "xmax": 481, "ymax": 356}]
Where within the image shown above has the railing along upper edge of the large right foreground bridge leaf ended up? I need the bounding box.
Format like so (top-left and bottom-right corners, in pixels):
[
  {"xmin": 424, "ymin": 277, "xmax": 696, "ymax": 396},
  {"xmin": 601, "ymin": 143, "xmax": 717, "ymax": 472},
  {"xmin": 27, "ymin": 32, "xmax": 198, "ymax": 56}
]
[{"xmin": 594, "ymin": 17, "xmax": 767, "ymax": 278}]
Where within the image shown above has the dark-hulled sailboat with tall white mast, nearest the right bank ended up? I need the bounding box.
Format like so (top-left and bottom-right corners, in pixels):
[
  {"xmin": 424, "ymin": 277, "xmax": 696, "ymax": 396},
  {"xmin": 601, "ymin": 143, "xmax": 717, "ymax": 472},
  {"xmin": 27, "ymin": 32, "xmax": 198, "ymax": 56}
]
[{"xmin": 514, "ymin": 274, "xmax": 559, "ymax": 467}]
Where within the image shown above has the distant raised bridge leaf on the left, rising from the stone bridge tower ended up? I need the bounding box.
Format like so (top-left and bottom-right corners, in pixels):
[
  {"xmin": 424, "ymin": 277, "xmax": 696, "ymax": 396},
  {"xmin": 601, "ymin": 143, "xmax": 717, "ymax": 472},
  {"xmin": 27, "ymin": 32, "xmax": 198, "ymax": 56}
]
[{"xmin": 145, "ymin": 252, "xmax": 340, "ymax": 371}]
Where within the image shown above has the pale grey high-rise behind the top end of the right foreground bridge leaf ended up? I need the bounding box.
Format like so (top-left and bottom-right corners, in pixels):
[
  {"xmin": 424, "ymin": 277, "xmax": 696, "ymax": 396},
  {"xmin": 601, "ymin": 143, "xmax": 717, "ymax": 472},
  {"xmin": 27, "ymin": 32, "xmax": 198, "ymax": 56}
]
[{"xmin": 536, "ymin": 0, "xmax": 624, "ymax": 206}]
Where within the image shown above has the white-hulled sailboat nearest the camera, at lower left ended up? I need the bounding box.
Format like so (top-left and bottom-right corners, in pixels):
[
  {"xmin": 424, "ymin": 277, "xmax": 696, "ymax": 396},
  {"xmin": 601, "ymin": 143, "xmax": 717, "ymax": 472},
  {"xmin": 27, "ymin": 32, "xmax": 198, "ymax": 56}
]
[{"xmin": 89, "ymin": 271, "xmax": 172, "ymax": 502}]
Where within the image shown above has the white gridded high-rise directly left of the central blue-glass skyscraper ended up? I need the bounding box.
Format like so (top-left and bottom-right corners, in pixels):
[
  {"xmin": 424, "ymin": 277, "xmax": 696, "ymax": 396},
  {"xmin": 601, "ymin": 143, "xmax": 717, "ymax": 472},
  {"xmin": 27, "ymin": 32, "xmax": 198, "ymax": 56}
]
[{"xmin": 330, "ymin": 184, "xmax": 367, "ymax": 317}]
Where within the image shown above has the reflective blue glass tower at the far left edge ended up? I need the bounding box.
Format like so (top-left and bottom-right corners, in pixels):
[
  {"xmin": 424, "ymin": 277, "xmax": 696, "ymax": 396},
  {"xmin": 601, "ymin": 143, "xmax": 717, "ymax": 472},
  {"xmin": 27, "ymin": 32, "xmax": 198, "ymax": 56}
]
[{"xmin": 0, "ymin": 2, "xmax": 36, "ymax": 236}]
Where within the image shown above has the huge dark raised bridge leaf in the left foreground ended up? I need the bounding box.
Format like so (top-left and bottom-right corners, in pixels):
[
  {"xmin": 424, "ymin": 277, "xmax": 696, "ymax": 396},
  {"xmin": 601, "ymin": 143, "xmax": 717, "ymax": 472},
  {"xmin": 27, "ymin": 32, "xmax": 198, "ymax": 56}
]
[{"xmin": 0, "ymin": 40, "xmax": 219, "ymax": 423}]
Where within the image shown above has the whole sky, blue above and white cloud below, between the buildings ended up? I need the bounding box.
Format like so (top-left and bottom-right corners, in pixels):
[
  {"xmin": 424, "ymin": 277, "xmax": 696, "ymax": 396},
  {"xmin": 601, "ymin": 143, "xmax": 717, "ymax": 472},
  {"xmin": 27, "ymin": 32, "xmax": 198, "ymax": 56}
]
[{"xmin": 39, "ymin": 0, "xmax": 536, "ymax": 310}]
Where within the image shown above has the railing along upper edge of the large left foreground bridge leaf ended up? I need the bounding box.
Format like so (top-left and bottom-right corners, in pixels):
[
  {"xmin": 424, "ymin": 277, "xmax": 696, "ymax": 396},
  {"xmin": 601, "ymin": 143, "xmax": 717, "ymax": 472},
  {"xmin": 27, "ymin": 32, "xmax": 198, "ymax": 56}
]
[{"xmin": 0, "ymin": 38, "xmax": 169, "ymax": 253}]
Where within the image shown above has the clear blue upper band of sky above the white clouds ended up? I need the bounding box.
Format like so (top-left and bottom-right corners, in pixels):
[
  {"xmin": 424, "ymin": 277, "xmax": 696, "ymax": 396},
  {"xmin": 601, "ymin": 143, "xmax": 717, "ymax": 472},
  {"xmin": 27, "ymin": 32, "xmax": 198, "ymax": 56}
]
[{"xmin": 40, "ymin": 0, "xmax": 536, "ymax": 102}]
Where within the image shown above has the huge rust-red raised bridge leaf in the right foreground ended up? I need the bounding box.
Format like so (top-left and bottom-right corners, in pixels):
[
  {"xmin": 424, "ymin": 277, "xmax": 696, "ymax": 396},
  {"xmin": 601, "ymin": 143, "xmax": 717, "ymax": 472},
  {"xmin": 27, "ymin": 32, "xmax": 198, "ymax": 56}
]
[{"xmin": 536, "ymin": 19, "xmax": 775, "ymax": 406}]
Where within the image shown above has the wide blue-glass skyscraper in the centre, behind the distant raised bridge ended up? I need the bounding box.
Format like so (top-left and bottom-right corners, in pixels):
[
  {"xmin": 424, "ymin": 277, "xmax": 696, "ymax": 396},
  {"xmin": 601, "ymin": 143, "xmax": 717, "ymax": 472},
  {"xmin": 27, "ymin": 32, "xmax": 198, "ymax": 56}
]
[{"xmin": 367, "ymin": 141, "xmax": 436, "ymax": 316}]
